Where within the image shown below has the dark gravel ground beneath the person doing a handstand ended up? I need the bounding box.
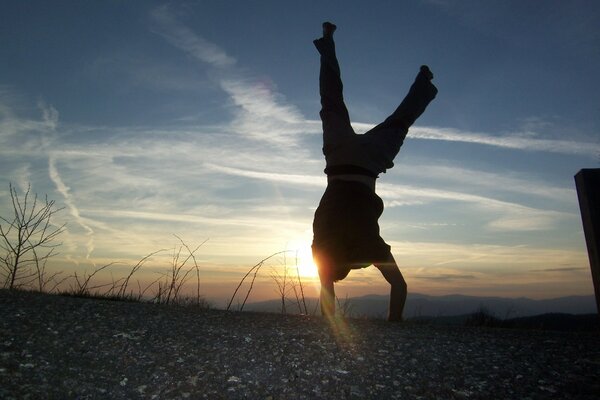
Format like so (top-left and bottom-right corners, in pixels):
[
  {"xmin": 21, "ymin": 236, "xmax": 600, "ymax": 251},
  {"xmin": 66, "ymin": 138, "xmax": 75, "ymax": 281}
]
[{"xmin": 0, "ymin": 291, "xmax": 600, "ymax": 399}]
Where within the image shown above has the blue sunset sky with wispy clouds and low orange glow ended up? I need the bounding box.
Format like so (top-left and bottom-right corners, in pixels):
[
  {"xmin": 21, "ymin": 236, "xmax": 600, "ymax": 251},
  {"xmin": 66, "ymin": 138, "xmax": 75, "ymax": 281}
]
[{"xmin": 0, "ymin": 0, "xmax": 600, "ymax": 304}]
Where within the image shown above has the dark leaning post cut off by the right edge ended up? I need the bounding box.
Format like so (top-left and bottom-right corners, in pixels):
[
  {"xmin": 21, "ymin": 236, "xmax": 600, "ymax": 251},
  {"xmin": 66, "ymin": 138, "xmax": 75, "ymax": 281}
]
[{"xmin": 575, "ymin": 168, "xmax": 600, "ymax": 313}]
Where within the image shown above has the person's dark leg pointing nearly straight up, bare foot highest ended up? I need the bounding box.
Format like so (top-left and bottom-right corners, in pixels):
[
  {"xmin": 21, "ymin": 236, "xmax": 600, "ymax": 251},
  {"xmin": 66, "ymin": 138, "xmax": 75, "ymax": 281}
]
[{"xmin": 313, "ymin": 22, "xmax": 354, "ymax": 153}]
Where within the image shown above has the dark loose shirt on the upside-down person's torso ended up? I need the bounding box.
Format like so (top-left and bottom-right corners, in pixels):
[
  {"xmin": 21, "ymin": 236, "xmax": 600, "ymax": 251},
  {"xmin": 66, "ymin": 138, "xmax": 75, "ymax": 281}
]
[{"xmin": 312, "ymin": 180, "xmax": 391, "ymax": 281}]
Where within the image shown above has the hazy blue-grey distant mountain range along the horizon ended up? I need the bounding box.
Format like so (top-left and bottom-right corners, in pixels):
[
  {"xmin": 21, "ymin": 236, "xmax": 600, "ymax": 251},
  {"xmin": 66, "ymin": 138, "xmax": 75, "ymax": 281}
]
[{"xmin": 244, "ymin": 293, "xmax": 597, "ymax": 319}]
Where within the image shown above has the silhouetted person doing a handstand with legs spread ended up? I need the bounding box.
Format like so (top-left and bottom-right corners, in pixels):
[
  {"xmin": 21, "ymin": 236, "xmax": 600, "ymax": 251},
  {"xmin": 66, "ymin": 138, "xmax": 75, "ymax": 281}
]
[{"xmin": 312, "ymin": 22, "xmax": 437, "ymax": 321}]
